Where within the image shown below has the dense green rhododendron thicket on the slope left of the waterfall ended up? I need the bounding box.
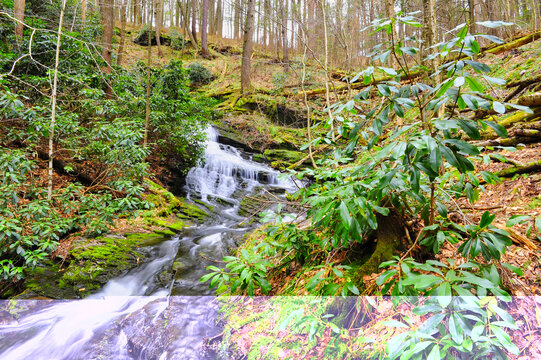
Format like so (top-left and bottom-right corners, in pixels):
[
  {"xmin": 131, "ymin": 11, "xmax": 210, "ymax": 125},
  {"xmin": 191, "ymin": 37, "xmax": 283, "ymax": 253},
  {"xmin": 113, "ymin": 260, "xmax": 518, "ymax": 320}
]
[{"xmin": 0, "ymin": 3, "xmax": 215, "ymax": 290}]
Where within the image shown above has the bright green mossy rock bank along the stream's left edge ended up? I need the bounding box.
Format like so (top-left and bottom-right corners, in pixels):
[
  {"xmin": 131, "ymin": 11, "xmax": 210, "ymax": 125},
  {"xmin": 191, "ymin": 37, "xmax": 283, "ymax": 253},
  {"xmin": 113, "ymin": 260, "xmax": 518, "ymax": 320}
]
[{"xmin": 18, "ymin": 180, "xmax": 208, "ymax": 299}]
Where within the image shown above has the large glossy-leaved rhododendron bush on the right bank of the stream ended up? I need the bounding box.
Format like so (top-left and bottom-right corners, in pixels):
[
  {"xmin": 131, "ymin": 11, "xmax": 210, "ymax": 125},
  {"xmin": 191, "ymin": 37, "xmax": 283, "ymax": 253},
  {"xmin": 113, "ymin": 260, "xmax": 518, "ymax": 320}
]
[{"xmin": 201, "ymin": 14, "xmax": 531, "ymax": 359}]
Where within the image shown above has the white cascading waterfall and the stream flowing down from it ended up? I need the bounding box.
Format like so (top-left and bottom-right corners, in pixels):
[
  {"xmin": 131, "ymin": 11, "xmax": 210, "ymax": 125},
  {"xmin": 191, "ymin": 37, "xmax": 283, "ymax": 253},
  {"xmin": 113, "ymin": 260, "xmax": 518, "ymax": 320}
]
[{"xmin": 0, "ymin": 128, "xmax": 294, "ymax": 360}]
